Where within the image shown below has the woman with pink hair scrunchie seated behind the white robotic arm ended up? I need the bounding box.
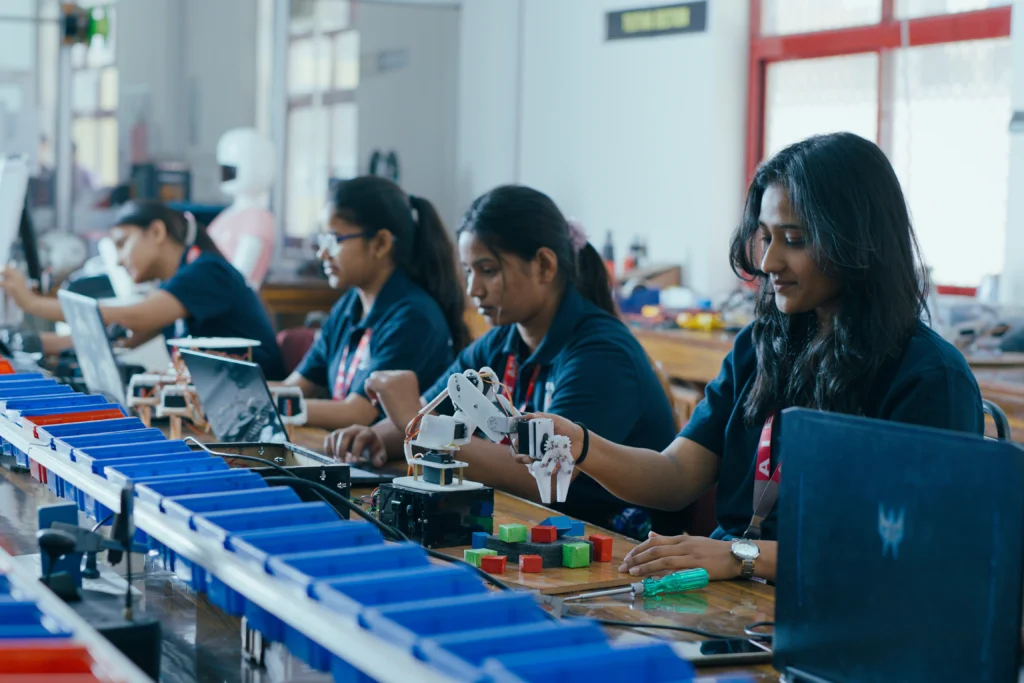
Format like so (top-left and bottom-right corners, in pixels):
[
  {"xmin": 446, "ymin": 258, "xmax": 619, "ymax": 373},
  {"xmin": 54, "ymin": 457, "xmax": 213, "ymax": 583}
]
[{"xmin": 329, "ymin": 186, "xmax": 675, "ymax": 527}]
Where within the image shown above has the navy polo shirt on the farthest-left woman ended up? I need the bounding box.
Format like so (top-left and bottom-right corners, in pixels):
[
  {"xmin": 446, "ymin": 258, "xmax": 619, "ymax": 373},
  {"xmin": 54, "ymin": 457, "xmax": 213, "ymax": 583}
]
[{"xmin": 161, "ymin": 250, "xmax": 286, "ymax": 382}]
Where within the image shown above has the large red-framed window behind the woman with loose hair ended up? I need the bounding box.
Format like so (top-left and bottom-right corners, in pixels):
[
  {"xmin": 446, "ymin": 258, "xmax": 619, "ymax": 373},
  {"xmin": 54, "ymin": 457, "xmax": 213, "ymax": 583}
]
[{"xmin": 746, "ymin": 0, "xmax": 1011, "ymax": 286}]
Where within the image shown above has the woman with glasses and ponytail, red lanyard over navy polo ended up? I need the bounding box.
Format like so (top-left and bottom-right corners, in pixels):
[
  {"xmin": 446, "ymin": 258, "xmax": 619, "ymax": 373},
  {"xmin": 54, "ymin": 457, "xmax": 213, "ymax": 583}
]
[{"xmin": 287, "ymin": 176, "xmax": 469, "ymax": 429}]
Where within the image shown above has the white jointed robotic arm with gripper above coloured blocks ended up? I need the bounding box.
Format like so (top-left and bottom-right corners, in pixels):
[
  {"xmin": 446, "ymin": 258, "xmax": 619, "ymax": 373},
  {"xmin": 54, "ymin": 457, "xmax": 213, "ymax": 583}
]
[{"xmin": 393, "ymin": 368, "xmax": 575, "ymax": 503}]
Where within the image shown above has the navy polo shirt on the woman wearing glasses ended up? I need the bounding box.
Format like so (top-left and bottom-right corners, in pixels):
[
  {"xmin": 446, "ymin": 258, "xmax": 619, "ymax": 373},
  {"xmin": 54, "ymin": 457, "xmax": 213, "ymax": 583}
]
[{"xmin": 298, "ymin": 270, "xmax": 454, "ymax": 405}]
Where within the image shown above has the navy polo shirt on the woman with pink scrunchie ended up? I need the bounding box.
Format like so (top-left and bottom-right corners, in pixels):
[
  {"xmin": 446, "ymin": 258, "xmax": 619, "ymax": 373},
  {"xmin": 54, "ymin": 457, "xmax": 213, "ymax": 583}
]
[{"xmin": 424, "ymin": 287, "xmax": 676, "ymax": 527}]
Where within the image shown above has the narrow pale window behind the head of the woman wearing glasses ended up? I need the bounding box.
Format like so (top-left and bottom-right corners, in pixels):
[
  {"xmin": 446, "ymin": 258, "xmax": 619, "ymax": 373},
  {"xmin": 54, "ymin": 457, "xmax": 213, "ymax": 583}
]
[{"xmin": 285, "ymin": 0, "xmax": 359, "ymax": 244}]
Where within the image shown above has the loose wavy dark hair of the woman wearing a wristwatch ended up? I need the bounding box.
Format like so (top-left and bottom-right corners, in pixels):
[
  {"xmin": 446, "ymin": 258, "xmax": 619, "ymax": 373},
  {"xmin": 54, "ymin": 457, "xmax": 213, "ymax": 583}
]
[{"xmin": 731, "ymin": 133, "xmax": 928, "ymax": 424}]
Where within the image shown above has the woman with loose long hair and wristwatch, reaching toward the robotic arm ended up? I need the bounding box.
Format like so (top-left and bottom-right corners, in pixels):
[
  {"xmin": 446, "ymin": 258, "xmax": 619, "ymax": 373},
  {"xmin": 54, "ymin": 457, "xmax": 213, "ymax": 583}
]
[{"xmin": 520, "ymin": 133, "xmax": 984, "ymax": 581}]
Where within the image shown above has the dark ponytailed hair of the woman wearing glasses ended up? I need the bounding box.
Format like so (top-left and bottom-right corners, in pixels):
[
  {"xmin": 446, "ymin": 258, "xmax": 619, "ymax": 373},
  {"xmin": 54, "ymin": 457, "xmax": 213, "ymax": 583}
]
[{"xmin": 331, "ymin": 175, "xmax": 470, "ymax": 352}]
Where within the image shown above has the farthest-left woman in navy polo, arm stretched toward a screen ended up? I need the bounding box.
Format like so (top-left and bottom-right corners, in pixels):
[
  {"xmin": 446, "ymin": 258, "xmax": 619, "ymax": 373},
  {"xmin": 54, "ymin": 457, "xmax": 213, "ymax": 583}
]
[{"xmin": 2, "ymin": 201, "xmax": 285, "ymax": 380}]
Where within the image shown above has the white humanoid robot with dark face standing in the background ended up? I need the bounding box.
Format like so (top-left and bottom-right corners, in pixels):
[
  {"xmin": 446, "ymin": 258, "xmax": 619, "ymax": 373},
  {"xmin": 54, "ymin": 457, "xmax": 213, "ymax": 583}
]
[{"xmin": 208, "ymin": 128, "xmax": 274, "ymax": 289}]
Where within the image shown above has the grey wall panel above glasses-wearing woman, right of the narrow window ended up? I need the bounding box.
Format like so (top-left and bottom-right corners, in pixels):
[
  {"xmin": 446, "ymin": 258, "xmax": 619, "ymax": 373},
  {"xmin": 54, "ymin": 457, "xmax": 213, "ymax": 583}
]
[{"xmin": 356, "ymin": 4, "xmax": 459, "ymax": 226}]
